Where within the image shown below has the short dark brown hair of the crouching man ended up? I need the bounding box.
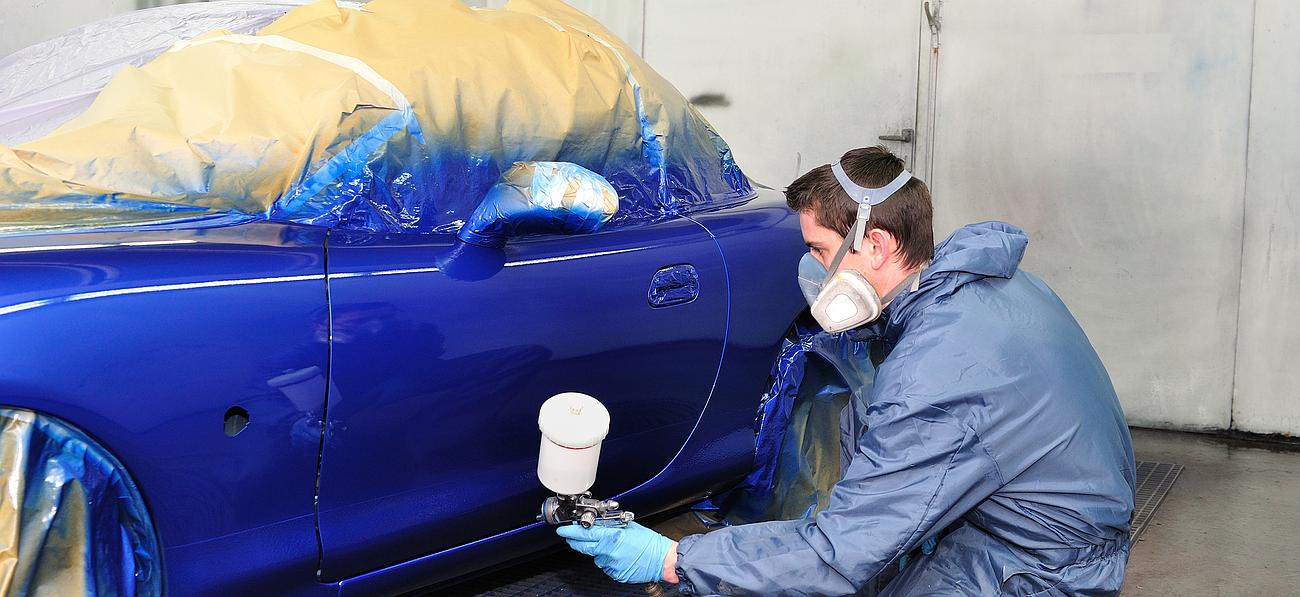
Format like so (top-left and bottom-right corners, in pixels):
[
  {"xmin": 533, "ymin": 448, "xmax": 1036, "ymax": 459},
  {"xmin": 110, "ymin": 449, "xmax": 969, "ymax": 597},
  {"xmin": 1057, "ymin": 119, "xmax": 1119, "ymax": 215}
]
[{"xmin": 785, "ymin": 146, "xmax": 935, "ymax": 268}]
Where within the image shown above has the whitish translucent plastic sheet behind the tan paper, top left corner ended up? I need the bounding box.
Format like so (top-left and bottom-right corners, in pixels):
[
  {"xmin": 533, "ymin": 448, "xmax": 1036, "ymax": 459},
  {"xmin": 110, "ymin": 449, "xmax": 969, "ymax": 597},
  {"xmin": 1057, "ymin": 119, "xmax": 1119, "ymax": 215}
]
[{"xmin": 0, "ymin": 0, "xmax": 307, "ymax": 146}]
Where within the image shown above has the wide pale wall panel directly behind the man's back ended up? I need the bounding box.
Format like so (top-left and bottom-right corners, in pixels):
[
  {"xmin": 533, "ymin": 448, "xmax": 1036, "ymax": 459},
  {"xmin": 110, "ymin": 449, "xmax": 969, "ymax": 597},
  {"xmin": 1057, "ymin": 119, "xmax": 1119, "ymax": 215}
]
[{"xmin": 931, "ymin": 0, "xmax": 1253, "ymax": 428}]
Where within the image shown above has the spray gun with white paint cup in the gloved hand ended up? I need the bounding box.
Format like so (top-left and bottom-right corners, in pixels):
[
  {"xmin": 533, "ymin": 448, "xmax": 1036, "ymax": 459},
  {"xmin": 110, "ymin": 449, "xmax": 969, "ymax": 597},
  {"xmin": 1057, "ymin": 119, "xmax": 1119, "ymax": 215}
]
[{"xmin": 537, "ymin": 391, "xmax": 634, "ymax": 528}]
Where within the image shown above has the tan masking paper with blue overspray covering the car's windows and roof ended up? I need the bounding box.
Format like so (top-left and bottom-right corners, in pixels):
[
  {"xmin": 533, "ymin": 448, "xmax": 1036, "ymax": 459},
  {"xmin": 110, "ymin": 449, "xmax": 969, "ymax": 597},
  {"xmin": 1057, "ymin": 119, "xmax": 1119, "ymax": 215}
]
[{"xmin": 0, "ymin": 0, "xmax": 751, "ymax": 233}]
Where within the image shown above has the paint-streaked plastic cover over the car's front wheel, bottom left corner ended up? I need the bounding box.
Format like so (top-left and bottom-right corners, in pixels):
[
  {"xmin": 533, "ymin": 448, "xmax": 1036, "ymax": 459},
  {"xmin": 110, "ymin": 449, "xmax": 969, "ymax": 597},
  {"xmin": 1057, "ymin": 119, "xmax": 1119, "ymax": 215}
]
[{"xmin": 0, "ymin": 408, "xmax": 163, "ymax": 597}]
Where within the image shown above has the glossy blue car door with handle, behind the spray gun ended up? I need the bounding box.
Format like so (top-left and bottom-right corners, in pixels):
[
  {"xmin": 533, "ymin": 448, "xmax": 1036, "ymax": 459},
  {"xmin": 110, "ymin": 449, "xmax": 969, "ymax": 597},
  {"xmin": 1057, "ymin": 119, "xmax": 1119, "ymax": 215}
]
[{"xmin": 310, "ymin": 219, "xmax": 728, "ymax": 580}]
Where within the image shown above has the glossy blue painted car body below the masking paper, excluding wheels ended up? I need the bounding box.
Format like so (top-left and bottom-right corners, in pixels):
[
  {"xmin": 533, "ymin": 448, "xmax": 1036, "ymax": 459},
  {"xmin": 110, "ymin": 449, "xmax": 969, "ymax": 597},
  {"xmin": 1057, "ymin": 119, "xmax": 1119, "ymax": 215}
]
[{"xmin": 0, "ymin": 190, "xmax": 805, "ymax": 594}]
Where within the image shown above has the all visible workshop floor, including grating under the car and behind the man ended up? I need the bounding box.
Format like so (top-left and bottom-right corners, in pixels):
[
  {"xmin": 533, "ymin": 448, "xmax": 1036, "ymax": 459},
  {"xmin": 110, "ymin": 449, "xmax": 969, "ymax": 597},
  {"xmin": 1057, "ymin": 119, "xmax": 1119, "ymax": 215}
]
[{"xmin": 439, "ymin": 429, "xmax": 1300, "ymax": 597}]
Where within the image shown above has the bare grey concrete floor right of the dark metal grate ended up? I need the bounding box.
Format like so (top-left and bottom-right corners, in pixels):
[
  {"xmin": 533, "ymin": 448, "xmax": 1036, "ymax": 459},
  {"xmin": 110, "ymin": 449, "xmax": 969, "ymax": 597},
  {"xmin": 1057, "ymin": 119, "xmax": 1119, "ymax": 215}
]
[{"xmin": 1123, "ymin": 429, "xmax": 1300, "ymax": 597}]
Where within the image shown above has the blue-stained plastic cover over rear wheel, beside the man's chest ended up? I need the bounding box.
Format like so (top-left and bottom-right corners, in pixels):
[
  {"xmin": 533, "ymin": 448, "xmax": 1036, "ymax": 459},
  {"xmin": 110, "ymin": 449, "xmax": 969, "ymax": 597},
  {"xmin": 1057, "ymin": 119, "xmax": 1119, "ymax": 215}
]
[{"xmin": 714, "ymin": 326, "xmax": 875, "ymax": 524}]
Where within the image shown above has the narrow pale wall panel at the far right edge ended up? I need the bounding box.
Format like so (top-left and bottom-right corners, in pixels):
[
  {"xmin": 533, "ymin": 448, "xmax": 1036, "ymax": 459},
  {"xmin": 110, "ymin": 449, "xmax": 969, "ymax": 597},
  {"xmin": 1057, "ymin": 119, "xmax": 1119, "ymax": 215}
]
[{"xmin": 1232, "ymin": 0, "xmax": 1300, "ymax": 434}]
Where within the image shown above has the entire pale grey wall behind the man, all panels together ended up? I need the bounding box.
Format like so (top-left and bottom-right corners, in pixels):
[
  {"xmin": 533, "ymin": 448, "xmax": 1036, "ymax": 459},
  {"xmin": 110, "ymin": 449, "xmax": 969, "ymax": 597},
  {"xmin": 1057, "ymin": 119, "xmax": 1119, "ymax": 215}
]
[{"xmin": 582, "ymin": 0, "xmax": 1300, "ymax": 434}]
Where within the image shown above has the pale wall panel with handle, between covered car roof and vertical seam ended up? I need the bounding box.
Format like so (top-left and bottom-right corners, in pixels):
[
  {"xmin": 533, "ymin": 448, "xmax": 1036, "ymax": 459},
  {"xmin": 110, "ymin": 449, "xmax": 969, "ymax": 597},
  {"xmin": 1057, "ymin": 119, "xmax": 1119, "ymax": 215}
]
[{"xmin": 644, "ymin": 0, "xmax": 920, "ymax": 187}]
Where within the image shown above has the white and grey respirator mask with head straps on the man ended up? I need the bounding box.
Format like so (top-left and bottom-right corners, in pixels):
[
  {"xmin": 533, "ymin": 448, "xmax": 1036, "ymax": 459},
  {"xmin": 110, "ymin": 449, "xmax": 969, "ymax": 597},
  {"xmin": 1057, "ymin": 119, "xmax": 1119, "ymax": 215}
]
[{"xmin": 800, "ymin": 161, "xmax": 918, "ymax": 333}]
